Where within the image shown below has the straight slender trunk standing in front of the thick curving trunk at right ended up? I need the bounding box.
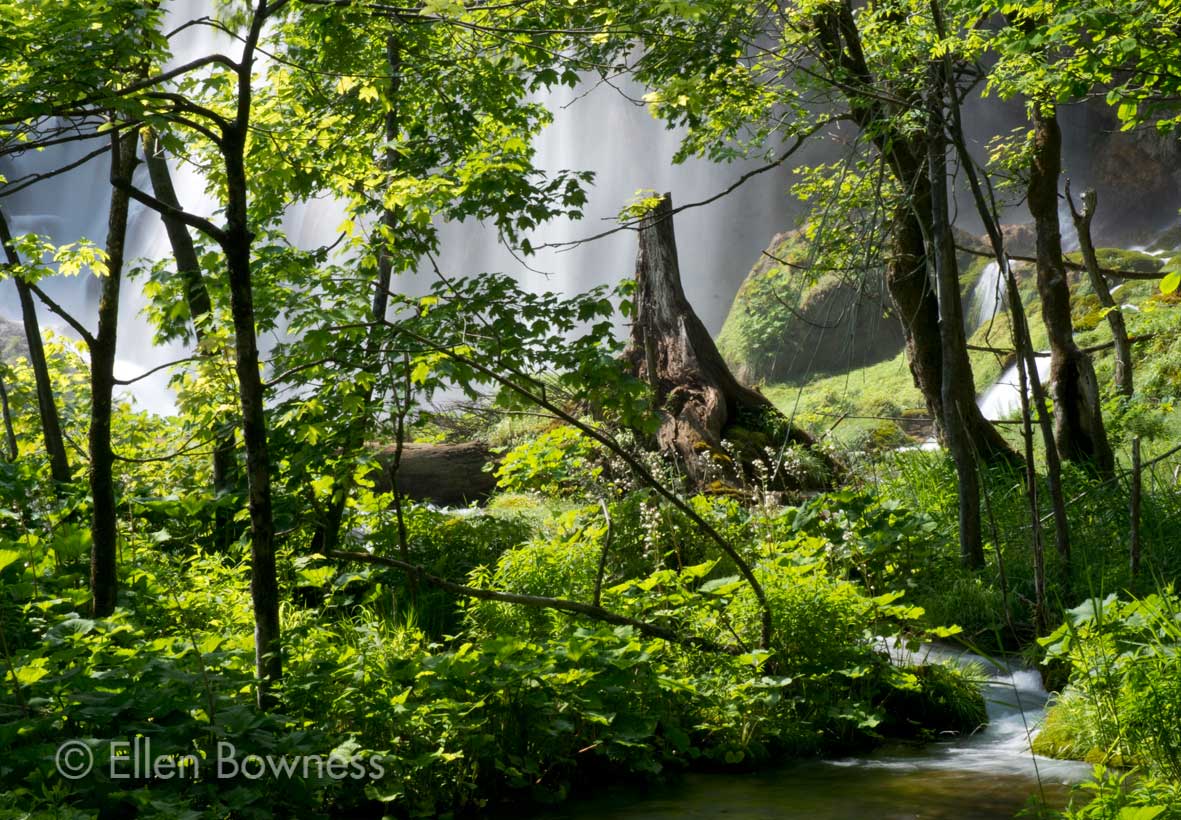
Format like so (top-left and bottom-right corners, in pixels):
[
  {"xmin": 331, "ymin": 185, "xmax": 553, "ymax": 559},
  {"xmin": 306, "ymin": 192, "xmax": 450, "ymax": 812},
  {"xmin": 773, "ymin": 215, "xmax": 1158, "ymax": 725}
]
[{"xmin": 927, "ymin": 63, "xmax": 984, "ymax": 570}]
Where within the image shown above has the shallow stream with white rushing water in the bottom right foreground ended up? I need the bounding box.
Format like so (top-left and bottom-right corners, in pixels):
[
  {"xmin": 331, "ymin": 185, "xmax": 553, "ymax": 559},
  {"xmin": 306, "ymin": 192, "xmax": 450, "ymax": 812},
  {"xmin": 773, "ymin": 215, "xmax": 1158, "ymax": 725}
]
[{"xmin": 537, "ymin": 647, "xmax": 1091, "ymax": 820}]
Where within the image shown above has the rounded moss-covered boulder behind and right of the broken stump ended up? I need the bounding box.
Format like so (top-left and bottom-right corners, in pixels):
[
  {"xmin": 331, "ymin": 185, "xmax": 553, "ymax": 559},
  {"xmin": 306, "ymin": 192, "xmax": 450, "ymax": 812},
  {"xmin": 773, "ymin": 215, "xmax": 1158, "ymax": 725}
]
[{"xmin": 718, "ymin": 232, "xmax": 903, "ymax": 384}]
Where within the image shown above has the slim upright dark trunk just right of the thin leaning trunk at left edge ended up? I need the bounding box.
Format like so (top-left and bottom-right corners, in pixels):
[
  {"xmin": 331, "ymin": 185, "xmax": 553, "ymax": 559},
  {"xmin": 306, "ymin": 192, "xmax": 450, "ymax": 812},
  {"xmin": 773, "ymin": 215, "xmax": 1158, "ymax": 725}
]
[{"xmin": 90, "ymin": 131, "xmax": 137, "ymax": 618}]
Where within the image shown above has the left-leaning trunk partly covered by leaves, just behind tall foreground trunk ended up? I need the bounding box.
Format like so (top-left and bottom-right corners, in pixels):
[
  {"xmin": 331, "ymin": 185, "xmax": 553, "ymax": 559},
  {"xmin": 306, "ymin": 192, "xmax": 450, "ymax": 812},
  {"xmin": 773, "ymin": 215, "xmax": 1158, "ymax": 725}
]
[{"xmin": 144, "ymin": 131, "xmax": 237, "ymax": 549}]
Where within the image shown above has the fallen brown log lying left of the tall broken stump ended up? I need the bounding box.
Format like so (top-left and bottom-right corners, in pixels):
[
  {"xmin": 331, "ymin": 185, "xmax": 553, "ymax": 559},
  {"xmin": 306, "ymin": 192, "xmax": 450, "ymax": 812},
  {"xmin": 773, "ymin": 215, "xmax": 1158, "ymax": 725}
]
[{"xmin": 370, "ymin": 442, "xmax": 498, "ymax": 507}]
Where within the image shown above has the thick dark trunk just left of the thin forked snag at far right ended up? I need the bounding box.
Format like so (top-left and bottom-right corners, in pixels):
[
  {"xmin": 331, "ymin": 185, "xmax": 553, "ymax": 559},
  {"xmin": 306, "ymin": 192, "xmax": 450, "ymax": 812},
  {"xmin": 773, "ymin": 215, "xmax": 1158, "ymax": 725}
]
[{"xmin": 1029, "ymin": 105, "xmax": 1115, "ymax": 476}]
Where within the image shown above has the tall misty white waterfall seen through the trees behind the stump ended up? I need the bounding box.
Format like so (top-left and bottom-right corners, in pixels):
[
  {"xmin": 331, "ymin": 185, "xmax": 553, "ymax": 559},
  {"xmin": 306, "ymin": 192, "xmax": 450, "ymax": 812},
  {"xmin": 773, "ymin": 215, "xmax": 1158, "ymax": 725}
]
[{"xmin": 0, "ymin": 0, "xmax": 791, "ymax": 412}]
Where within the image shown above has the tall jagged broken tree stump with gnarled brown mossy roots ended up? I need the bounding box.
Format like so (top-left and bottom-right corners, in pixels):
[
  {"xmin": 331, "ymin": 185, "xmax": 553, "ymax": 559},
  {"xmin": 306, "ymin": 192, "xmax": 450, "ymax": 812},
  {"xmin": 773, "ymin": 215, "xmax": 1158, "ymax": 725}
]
[{"xmin": 625, "ymin": 194, "xmax": 836, "ymax": 490}]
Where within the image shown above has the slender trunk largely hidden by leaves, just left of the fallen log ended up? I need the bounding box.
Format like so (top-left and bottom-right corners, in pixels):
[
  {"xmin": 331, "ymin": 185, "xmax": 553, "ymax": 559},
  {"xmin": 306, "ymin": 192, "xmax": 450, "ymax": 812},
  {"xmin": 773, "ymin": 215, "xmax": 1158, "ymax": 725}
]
[{"xmin": 312, "ymin": 35, "xmax": 409, "ymax": 558}]
